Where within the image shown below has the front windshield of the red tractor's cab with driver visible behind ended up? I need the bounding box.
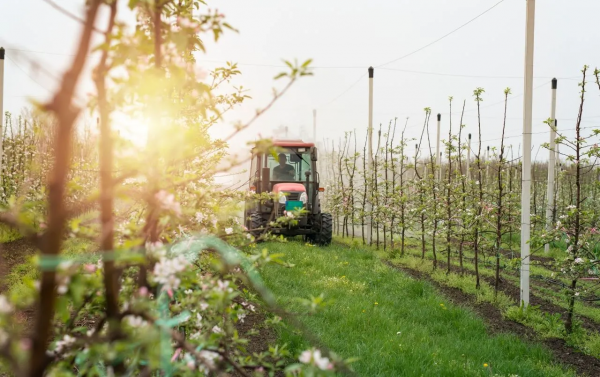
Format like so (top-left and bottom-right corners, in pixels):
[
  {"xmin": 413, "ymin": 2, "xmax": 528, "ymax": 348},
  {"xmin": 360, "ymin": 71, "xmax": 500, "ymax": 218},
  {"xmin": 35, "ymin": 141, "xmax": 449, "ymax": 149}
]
[{"xmin": 267, "ymin": 151, "xmax": 310, "ymax": 182}]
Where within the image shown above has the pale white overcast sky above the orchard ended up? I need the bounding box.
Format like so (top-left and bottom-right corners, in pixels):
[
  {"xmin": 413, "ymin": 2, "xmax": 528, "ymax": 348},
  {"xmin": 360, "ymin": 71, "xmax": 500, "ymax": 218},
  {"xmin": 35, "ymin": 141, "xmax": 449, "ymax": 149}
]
[{"xmin": 0, "ymin": 0, "xmax": 600, "ymax": 167}]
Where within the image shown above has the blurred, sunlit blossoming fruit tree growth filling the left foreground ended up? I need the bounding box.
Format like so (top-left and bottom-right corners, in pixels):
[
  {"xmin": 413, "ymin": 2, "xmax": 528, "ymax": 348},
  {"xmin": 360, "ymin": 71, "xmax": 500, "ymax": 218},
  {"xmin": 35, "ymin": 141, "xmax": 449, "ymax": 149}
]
[{"xmin": 0, "ymin": 0, "xmax": 332, "ymax": 377}]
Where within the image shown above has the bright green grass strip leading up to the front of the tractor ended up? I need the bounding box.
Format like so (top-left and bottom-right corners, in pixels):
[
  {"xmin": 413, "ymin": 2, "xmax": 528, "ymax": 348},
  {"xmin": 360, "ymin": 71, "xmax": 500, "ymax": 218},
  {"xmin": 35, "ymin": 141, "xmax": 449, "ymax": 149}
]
[{"xmin": 262, "ymin": 242, "xmax": 574, "ymax": 376}]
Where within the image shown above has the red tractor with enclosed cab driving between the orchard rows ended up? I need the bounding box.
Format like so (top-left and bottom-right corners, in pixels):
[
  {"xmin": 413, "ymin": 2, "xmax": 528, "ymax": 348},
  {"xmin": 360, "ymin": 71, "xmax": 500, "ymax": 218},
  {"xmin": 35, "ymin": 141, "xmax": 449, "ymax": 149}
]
[{"xmin": 244, "ymin": 140, "xmax": 332, "ymax": 246}]
